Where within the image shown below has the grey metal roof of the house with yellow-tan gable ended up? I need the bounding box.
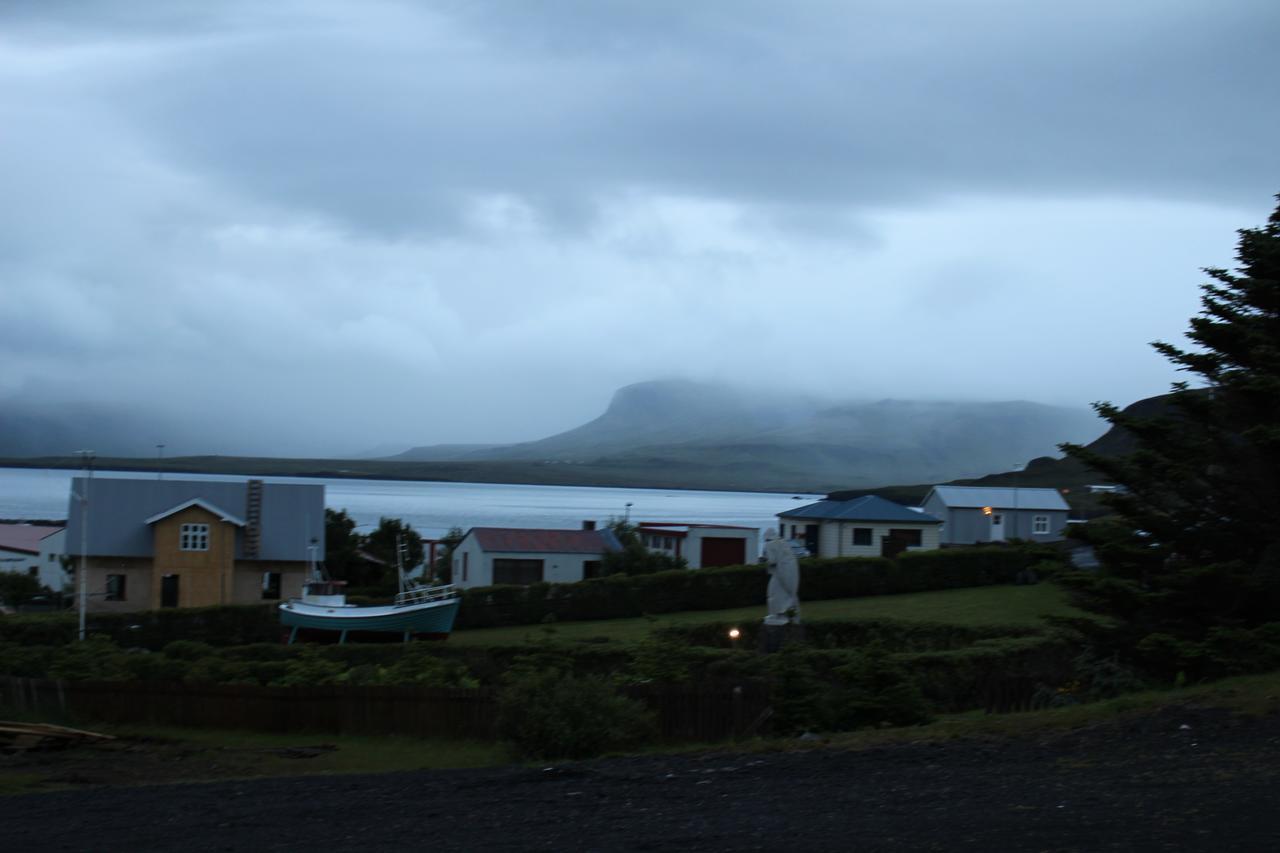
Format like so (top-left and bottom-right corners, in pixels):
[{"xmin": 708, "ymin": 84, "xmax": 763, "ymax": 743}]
[{"xmin": 67, "ymin": 476, "xmax": 324, "ymax": 561}]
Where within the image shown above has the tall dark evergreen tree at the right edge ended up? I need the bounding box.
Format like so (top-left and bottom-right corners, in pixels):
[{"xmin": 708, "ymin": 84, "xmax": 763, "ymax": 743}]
[{"xmin": 1062, "ymin": 196, "xmax": 1280, "ymax": 669}]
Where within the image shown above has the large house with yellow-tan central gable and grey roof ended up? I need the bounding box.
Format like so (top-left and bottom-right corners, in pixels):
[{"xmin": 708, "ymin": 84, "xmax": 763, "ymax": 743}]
[{"xmin": 67, "ymin": 476, "xmax": 324, "ymax": 611}]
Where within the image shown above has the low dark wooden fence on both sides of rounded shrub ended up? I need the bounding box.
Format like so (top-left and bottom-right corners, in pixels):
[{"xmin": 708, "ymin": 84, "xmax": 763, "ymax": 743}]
[{"xmin": 0, "ymin": 678, "xmax": 769, "ymax": 742}]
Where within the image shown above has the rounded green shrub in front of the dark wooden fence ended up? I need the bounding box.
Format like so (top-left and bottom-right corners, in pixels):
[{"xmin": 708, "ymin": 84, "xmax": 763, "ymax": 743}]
[{"xmin": 498, "ymin": 667, "xmax": 655, "ymax": 758}]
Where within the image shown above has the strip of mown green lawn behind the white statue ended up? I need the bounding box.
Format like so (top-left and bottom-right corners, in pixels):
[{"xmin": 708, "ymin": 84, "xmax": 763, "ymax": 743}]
[{"xmin": 448, "ymin": 583, "xmax": 1083, "ymax": 646}]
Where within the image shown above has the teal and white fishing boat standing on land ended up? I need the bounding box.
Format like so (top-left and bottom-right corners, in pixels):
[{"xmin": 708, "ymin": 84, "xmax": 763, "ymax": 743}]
[{"xmin": 280, "ymin": 535, "xmax": 461, "ymax": 643}]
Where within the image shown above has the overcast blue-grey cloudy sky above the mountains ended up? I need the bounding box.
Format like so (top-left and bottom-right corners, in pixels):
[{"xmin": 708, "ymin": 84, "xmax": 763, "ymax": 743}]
[{"xmin": 0, "ymin": 0, "xmax": 1280, "ymax": 455}]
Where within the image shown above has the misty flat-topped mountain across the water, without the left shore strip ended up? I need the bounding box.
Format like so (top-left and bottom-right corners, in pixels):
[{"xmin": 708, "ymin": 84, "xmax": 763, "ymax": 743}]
[{"xmin": 392, "ymin": 380, "xmax": 1101, "ymax": 489}]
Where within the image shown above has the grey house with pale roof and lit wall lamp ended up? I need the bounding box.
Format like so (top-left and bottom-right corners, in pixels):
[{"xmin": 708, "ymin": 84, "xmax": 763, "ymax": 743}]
[{"xmin": 922, "ymin": 485, "xmax": 1069, "ymax": 544}]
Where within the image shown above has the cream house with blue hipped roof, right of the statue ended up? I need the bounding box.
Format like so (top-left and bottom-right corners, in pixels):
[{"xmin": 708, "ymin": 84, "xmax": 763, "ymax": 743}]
[{"xmin": 778, "ymin": 494, "xmax": 942, "ymax": 558}]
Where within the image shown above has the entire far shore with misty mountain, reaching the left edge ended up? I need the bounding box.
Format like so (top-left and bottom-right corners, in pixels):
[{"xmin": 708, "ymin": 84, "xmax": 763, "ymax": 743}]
[{"xmin": 0, "ymin": 382, "xmax": 1131, "ymax": 492}]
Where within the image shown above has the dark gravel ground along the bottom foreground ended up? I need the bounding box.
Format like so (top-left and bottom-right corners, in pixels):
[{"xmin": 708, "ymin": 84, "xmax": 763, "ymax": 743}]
[{"xmin": 0, "ymin": 707, "xmax": 1280, "ymax": 853}]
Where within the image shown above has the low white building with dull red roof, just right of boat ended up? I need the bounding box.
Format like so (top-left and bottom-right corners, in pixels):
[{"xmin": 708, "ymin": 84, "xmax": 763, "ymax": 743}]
[{"xmin": 453, "ymin": 528, "xmax": 622, "ymax": 588}]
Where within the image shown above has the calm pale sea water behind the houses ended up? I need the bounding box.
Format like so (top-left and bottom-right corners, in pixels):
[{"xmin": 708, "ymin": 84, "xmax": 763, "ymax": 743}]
[{"xmin": 0, "ymin": 467, "xmax": 822, "ymax": 538}]
